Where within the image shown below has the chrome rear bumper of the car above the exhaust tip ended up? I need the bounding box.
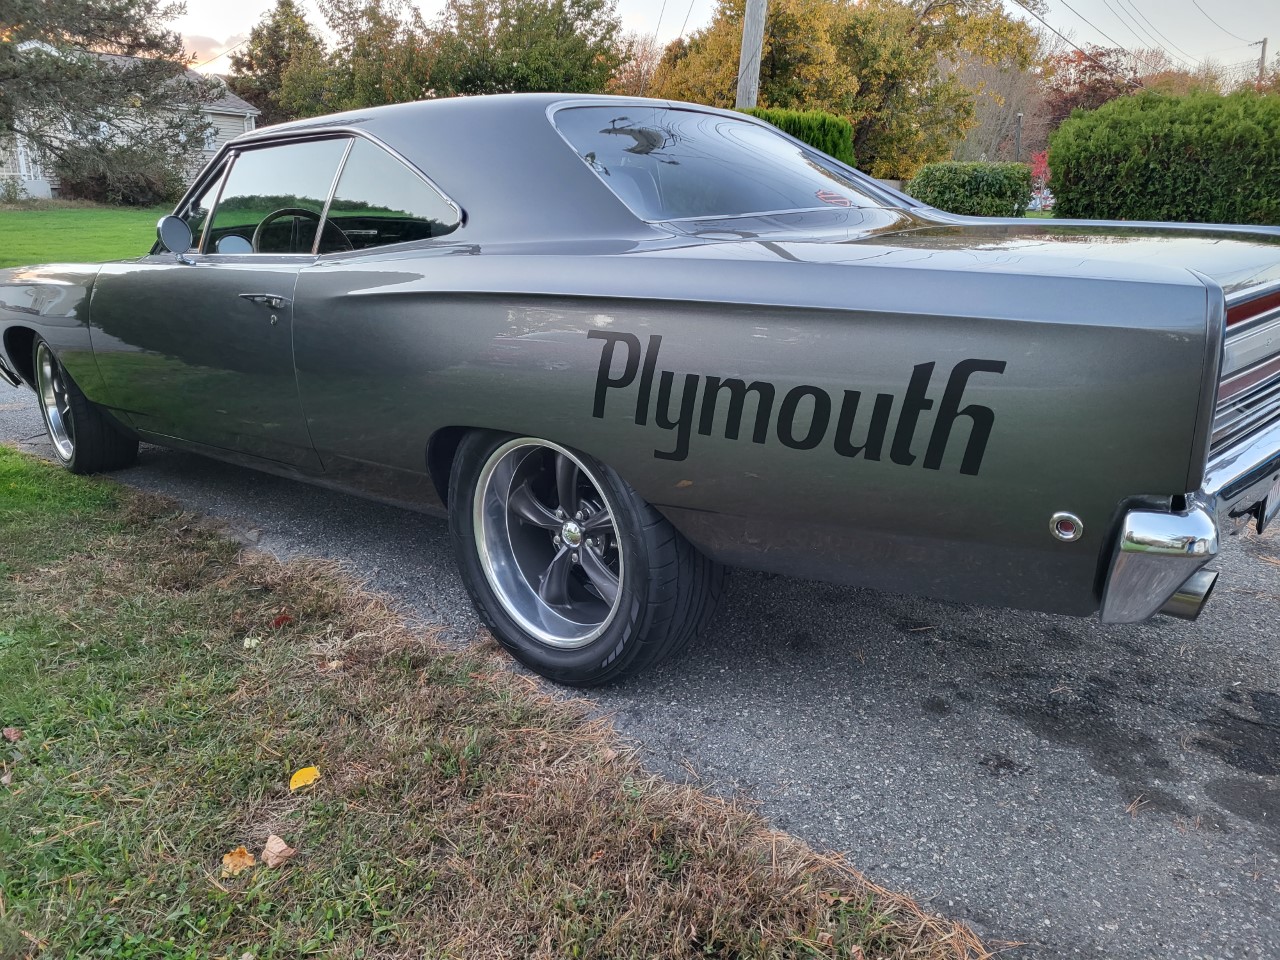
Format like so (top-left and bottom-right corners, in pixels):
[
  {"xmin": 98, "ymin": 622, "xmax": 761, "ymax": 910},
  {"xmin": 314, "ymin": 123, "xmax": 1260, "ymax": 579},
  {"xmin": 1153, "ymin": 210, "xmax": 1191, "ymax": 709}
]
[{"xmin": 1102, "ymin": 422, "xmax": 1280, "ymax": 623}]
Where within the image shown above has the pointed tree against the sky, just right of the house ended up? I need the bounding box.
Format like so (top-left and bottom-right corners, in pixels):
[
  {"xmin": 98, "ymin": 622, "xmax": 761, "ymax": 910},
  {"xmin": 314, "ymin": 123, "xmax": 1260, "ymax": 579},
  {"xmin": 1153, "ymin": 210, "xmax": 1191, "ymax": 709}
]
[{"xmin": 229, "ymin": 0, "xmax": 324, "ymax": 125}]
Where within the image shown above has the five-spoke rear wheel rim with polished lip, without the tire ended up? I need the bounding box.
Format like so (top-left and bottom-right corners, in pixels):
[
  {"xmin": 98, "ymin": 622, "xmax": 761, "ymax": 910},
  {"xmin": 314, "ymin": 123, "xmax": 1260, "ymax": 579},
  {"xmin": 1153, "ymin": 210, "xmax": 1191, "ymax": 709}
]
[{"xmin": 472, "ymin": 438, "xmax": 625, "ymax": 649}]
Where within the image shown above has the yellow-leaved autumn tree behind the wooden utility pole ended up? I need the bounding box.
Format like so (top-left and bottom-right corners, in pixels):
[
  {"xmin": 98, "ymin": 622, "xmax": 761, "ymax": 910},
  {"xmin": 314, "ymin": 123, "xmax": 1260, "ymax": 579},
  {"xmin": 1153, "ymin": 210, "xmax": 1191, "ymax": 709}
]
[{"xmin": 653, "ymin": 0, "xmax": 1037, "ymax": 177}]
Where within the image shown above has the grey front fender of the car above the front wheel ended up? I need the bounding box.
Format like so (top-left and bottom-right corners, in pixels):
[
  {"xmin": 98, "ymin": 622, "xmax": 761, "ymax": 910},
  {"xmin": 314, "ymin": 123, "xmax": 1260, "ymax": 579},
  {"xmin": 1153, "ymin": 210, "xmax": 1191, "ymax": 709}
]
[{"xmin": 0, "ymin": 264, "xmax": 101, "ymax": 399}]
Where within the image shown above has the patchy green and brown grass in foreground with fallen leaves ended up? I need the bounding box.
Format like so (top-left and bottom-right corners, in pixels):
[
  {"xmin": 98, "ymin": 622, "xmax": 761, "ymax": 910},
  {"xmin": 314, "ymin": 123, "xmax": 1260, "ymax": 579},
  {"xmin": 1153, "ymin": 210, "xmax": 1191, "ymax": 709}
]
[{"xmin": 0, "ymin": 448, "xmax": 988, "ymax": 960}]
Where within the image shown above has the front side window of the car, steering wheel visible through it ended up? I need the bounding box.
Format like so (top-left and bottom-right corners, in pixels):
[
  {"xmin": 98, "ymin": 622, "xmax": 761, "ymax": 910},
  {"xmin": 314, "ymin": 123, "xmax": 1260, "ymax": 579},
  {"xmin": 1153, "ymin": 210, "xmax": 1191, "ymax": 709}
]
[{"xmin": 205, "ymin": 140, "xmax": 349, "ymax": 253}]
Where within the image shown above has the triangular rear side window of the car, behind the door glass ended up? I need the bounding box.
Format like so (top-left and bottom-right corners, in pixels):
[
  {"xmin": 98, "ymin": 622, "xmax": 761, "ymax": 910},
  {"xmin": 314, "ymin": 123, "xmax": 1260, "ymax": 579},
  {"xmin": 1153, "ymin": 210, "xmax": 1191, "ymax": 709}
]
[{"xmin": 320, "ymin": 140, "xmax": 458, "ymax": 253}]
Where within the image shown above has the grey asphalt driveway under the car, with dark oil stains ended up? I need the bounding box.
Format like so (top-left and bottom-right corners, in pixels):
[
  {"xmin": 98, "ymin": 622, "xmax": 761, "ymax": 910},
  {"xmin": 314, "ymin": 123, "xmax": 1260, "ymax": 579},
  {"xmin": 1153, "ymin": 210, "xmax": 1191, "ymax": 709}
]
[{"xmin": 0, "ymin": 387, "xmax": 1280, "ymax": 959}]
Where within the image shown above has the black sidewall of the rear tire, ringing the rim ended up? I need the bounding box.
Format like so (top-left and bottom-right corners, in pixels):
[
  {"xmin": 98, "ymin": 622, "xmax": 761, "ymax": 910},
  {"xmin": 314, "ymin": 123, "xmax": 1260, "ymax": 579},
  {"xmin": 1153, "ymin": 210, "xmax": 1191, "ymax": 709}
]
[{"xmin": 449, "ymin": 431, "xmax": 652, "ymax": 685}]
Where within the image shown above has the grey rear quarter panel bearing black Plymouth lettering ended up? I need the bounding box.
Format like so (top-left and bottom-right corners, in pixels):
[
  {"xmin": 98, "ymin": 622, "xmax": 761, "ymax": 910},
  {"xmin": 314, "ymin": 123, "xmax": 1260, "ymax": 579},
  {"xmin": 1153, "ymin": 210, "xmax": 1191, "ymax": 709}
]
[{"xmin": 294, "ymin": 244, "xmax": 1216, "ymax": 613}]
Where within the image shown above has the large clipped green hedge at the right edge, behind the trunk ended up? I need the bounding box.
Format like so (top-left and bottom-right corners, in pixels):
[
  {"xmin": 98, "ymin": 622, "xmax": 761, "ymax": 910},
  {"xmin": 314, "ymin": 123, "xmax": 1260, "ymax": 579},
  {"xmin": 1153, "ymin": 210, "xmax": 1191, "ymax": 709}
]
[{"xmin": 1048, "ymin": 91, "xmax": 1280, "ymax": 224}]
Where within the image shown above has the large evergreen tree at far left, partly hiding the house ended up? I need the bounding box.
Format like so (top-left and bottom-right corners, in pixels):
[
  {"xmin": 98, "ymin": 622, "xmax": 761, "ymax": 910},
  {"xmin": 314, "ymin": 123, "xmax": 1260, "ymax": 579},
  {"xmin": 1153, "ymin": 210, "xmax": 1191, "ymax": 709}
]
[{"xmin": 0, "ymin": 0, "xmax": 218, "ymax": 165}]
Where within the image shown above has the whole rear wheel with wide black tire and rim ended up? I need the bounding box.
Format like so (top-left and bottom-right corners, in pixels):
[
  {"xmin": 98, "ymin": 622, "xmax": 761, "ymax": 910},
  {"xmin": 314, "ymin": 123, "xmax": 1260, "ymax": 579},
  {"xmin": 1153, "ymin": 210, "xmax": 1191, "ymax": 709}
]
[{"xmin": 449, "ymin": 431, "xmax": 724, "ymax": 686}]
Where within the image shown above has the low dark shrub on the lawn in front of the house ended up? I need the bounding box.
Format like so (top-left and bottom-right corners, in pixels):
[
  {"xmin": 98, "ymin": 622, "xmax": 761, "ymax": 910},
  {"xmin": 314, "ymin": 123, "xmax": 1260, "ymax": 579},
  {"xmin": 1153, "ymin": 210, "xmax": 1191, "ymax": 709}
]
[{"xmin": 54, "ymin": 145, "xmax": 186, "ymax": 206}]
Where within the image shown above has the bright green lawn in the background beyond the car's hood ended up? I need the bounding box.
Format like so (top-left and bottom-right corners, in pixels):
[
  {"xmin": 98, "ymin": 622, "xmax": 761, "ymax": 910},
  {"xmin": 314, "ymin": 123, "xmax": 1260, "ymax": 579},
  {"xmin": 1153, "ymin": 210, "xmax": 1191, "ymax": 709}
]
[{"xmin": 0, "ymin": 205, "xmax": 172, "ymax": 268}]
